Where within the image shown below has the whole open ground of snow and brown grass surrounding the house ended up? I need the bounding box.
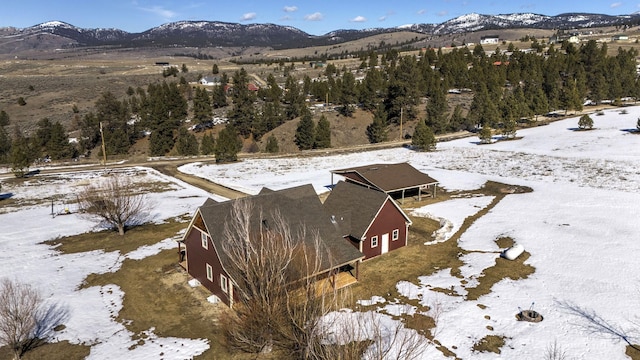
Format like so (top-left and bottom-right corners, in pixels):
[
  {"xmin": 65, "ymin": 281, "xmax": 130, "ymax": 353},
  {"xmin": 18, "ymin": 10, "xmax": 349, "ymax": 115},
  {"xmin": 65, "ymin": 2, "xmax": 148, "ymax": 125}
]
[{"xmin": 0, "ymin": 107, "xmax": 640, "ymax": 360}]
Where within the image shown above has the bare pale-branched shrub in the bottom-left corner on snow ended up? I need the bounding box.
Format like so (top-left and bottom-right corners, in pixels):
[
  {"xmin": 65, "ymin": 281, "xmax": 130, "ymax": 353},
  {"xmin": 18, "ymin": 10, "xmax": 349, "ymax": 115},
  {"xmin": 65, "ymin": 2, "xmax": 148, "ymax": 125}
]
[{"xmin": 0, "ymin": 279, "xmax": 68, "ymax": 359}]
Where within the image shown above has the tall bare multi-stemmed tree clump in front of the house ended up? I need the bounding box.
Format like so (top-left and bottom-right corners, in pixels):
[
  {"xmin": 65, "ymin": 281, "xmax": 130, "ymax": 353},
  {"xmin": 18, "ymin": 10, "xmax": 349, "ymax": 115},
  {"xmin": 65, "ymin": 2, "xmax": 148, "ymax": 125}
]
[{"xmin": 222, "ymin": 200, "xmax": 359, "ymax": 359}]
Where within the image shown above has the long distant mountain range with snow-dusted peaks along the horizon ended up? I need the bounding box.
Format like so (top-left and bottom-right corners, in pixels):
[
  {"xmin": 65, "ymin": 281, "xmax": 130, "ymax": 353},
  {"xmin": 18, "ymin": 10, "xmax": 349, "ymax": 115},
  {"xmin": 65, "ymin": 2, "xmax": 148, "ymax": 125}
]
[{"xmin": 0, "ymin": 13, "xmax": 640, "ymax": 55}]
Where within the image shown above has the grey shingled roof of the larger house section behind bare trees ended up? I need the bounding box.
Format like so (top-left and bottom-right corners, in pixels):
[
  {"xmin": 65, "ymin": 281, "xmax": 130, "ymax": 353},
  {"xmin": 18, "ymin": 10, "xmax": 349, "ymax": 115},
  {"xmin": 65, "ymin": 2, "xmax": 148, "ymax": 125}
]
[{"xmin": 199, "ymin": 184, "xmax": 364, "ymax": 277}]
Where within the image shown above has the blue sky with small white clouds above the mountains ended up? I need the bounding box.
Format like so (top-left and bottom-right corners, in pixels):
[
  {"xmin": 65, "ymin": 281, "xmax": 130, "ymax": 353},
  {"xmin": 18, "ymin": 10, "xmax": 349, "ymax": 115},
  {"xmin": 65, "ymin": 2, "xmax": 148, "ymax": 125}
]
[{"xmin": 5, "ymin": 0, "xmax": 640, "ymax": 35}]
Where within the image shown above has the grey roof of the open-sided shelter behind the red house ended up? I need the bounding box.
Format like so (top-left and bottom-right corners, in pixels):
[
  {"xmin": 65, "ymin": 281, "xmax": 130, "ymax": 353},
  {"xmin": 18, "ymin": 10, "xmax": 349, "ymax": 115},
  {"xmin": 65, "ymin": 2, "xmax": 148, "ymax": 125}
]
[{"xmin": 331, "ymin": 162, "xmax": 438, "ymax": 193}]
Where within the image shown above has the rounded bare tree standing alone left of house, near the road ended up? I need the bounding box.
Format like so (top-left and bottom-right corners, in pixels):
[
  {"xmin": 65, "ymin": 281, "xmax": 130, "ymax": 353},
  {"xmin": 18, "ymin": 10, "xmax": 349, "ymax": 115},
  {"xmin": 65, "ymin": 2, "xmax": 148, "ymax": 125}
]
[{"xmin": 78, "ymin": 174, "xmax": 148, "ymax": 235}]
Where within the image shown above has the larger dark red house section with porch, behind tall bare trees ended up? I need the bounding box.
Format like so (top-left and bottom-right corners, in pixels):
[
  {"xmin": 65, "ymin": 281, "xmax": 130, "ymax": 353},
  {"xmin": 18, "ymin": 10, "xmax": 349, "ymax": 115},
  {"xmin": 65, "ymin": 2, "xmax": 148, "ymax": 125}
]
[{"xmin": 181, "ymin": 185, "xmax": 364, "ymax": 307}]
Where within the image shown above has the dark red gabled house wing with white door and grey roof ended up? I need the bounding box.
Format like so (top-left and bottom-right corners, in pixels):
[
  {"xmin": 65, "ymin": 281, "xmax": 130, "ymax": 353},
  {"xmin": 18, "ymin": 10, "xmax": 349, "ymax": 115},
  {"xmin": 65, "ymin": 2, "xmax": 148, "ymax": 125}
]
[{"xmin": 324, "ymin": 181, "xmax": 411, "ymax": 259}]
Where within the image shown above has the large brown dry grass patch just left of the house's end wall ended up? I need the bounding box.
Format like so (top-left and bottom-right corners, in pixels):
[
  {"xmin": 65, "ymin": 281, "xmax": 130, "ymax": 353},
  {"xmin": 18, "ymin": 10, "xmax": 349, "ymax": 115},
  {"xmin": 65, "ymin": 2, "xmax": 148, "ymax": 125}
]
[{"xmin": 84, "ymin": 250, "xmax": 230, "ymax": 359}]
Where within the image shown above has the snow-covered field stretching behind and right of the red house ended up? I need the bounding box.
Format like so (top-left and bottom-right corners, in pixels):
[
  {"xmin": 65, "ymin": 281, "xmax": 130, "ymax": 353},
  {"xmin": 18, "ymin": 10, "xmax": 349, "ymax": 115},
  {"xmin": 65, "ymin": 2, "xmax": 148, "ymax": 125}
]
[{"xmin": 181, "ymin": 107, "xmax": 640, "ymax": 359}]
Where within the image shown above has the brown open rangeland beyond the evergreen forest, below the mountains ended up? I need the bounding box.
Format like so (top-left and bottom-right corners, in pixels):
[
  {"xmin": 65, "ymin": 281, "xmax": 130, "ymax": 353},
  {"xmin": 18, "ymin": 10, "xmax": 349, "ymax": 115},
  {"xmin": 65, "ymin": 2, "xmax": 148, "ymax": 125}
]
[{"xmin": 0, "ymin": 22, "xmax": 640, "ymax": 142}]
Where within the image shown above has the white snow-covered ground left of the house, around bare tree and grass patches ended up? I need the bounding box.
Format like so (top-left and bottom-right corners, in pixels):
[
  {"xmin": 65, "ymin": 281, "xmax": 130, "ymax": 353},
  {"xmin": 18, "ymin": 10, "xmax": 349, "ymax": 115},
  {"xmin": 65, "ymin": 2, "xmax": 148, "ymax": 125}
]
[{"xmin": 0, "ymin": 168, "xmax": 222, "ymax": 360}]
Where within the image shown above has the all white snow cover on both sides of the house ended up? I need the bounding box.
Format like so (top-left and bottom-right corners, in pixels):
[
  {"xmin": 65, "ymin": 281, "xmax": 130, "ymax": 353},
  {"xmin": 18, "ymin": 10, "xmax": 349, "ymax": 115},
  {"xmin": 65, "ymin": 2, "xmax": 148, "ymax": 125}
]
[{"xmin": 0, "ymin": 107, "xmax": 640, "ymax": 360}]
